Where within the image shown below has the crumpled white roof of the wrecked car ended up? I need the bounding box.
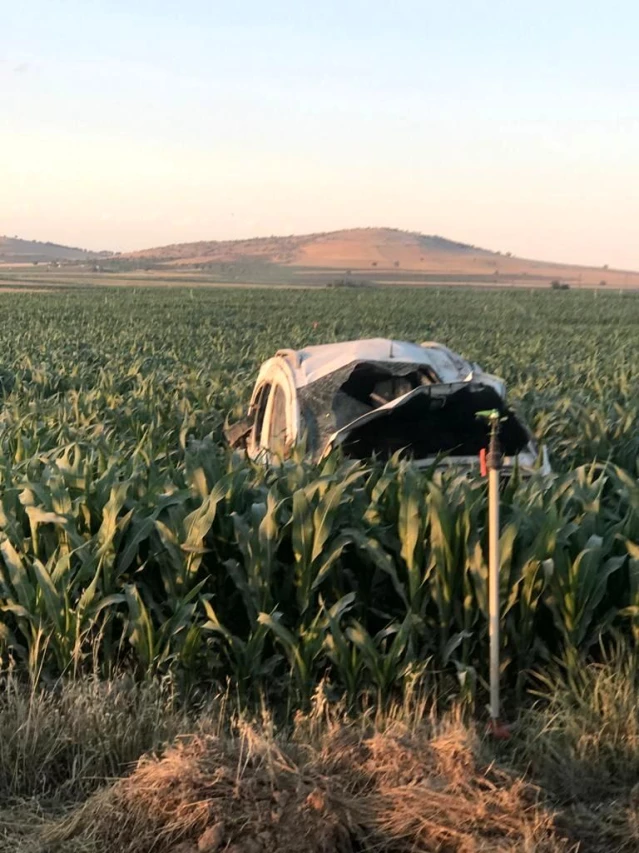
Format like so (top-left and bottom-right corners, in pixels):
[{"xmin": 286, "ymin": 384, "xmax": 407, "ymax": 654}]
[{"xmin": 277, "ymin": 338, "xmax": 473, "ymax": 388}]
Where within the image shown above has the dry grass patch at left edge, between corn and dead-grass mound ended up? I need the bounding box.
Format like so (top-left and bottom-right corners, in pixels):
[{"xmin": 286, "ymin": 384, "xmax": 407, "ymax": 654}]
[{"xmin": 0, "ymin": 675, "xmax": 200, "ymax": 803}]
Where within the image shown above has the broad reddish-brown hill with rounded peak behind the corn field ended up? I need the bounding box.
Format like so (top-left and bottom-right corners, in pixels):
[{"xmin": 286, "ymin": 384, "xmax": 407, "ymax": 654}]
[{"xmin": 120, "ymin": 228, "xmax": 639, "ymax": 288}]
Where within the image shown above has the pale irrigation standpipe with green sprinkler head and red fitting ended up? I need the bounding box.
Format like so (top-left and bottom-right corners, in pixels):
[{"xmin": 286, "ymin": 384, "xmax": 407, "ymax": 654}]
[{"xmin": 478, "ymin": 409, "xmax": 508, "ymax": 738}]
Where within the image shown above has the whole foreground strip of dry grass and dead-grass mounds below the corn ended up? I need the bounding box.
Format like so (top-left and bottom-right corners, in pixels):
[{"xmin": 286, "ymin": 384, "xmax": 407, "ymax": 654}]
[{"xmin": 6, "ymin": 654, "xmax": 639, "ymax": 853}]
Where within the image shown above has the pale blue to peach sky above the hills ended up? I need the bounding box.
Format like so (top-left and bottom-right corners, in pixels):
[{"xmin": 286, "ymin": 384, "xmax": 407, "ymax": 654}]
[{"xmin": 0, "ymin": 0, "xmax": 639, "ymax": 269}]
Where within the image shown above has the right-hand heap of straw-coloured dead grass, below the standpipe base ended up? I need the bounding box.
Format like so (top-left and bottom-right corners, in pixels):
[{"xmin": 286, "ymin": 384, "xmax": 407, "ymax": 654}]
[{"xmin": 328, "ymin": 722, "xmax": 568, "ymax": 853}]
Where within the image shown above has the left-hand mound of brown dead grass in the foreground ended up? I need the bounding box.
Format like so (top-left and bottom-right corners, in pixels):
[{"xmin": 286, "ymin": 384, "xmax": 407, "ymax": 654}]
[{"xmin": 44, "ymin": 727, "xmax": 358, "ymax": 853}]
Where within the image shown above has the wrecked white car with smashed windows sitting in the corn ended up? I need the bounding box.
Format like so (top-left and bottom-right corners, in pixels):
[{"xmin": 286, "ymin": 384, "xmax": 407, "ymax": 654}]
[{"xmin": 226, "ymin": 338, "xmax": 550, "ymax": 473}]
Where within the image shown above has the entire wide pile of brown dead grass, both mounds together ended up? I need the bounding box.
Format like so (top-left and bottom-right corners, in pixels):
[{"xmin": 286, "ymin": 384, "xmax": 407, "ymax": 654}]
[{"xmin": 44, "ymin": 712, "xmax": 569, "ymax": 853}]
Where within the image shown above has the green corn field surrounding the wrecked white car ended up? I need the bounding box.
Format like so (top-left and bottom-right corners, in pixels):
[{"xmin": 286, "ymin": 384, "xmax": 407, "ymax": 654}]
[{"xmin": 0, "ymin": 289, "xmax": 639, "ymax": 705}]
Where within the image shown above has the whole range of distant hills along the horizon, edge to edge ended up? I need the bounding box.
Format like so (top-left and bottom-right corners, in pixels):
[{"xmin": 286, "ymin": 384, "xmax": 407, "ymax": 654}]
[{"xmin": 6, "ymin": 228, "xmax": 639, "ymax": 289}]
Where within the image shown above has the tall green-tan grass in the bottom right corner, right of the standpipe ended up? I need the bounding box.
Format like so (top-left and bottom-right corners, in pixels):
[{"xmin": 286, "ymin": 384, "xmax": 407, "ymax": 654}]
[{"xmin": 503, "ymin": 650, "xmax": 639, "ymax": 853}]
